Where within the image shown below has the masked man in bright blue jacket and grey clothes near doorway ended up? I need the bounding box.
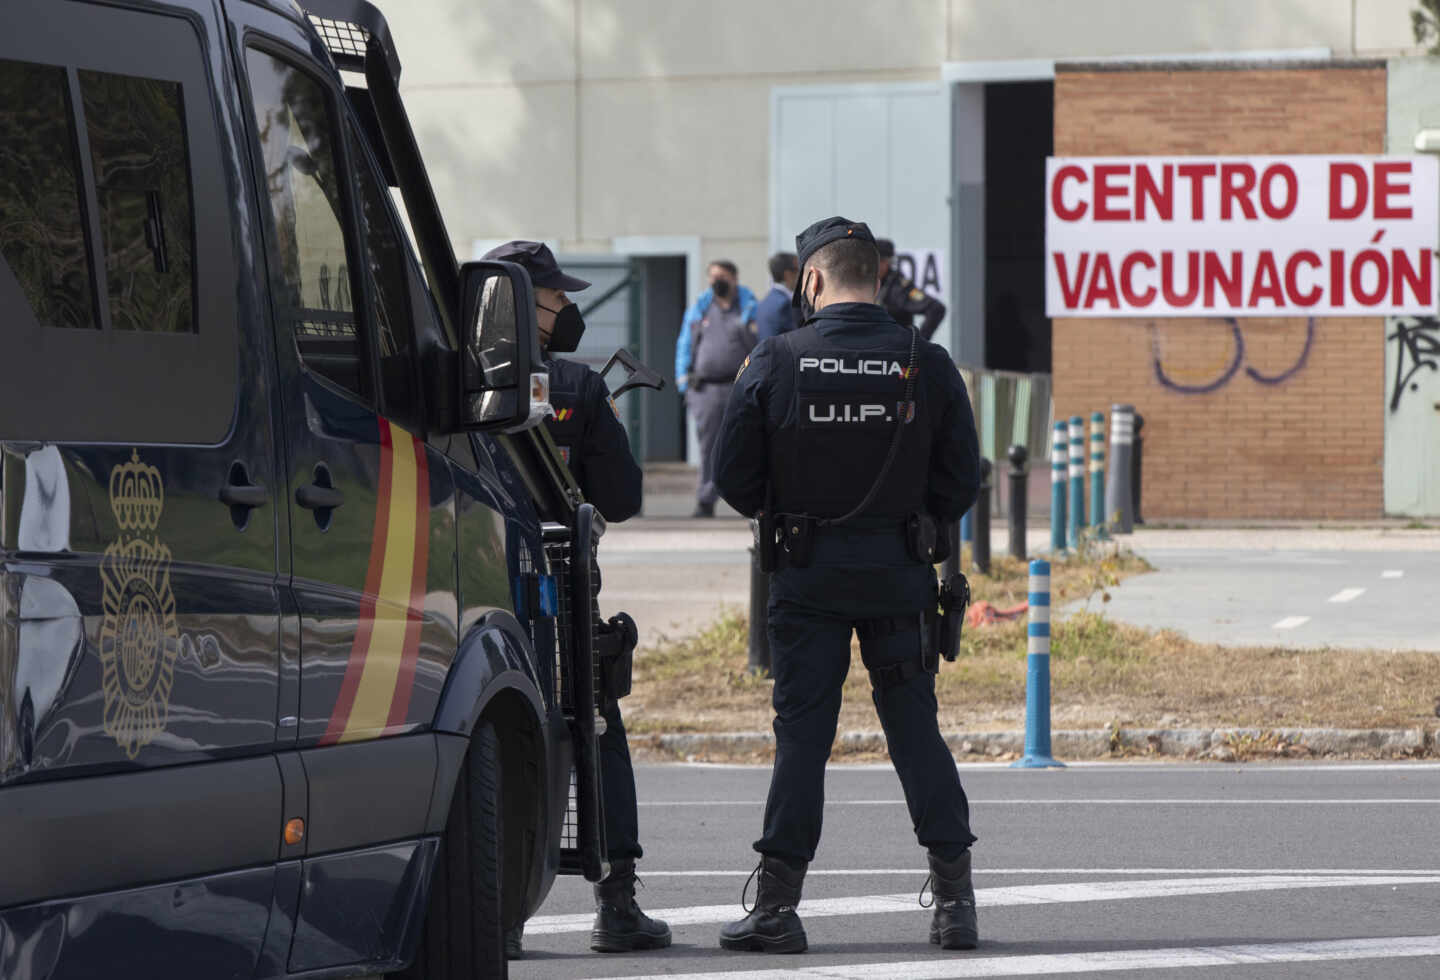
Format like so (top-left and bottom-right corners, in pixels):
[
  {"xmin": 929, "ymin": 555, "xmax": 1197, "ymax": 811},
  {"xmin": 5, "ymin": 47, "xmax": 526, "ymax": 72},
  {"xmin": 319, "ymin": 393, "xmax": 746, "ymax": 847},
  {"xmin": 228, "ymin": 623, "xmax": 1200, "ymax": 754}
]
[{"xmin": 675, "ymin": 259, "xmax": 757, "ymax": 517}]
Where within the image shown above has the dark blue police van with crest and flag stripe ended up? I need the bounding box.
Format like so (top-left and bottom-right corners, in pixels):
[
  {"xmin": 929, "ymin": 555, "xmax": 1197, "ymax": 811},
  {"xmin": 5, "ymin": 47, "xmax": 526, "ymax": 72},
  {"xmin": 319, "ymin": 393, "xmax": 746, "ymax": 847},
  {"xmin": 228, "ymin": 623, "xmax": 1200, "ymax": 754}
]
[{"xmin": 0, "ymin": 0, "xmax": 605, "ymax": 980}]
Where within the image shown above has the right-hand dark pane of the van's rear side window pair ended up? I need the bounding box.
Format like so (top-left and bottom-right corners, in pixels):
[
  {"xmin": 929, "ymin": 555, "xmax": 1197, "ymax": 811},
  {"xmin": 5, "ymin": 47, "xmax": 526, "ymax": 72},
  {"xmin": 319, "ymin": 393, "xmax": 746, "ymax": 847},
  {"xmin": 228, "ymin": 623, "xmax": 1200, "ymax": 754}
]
[{"xmin": 79, "ymin": 71, "xmax": 196, "ymax": 334}]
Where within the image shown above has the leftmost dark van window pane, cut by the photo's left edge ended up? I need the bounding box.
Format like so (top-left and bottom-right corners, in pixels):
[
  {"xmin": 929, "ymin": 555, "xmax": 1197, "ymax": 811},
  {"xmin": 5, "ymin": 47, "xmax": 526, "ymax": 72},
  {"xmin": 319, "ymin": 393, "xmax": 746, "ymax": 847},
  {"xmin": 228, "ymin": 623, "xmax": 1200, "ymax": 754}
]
[{"xmin": 0, "ymin": 60, "xmax": 99, "ymax": 328}]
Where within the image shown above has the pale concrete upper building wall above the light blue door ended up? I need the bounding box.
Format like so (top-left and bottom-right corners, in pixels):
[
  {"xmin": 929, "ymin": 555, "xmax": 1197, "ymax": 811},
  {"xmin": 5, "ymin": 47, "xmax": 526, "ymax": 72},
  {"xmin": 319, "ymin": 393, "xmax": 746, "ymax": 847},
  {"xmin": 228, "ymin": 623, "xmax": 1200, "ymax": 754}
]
[{"xmin": 379, "ymin": 0, "xmax": 1428, "ymax": 286}]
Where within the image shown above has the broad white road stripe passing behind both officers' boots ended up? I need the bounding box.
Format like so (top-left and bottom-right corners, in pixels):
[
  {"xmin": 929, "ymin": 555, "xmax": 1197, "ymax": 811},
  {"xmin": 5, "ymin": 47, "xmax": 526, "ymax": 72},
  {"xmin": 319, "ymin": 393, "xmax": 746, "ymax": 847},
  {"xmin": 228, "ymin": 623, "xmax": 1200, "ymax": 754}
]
[{"xmin": 526, "ymin": 875, "xmax": 1440, "ymax": 935}]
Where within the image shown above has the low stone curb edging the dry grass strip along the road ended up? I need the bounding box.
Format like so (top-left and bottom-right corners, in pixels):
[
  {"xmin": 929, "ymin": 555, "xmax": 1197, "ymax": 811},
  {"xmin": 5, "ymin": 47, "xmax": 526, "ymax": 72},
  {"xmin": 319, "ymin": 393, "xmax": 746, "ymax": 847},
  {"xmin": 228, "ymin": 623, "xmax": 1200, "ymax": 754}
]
[{"xmin": 629, "ymin": 727, "xmax": 1440, "ymax": 763}]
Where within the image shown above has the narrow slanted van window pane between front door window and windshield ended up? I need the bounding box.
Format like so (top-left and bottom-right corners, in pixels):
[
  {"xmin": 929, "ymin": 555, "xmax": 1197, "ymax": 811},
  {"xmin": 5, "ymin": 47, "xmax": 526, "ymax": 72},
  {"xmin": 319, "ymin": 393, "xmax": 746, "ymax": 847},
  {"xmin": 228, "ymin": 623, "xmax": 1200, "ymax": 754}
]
[{"xmin": 348, "ymin": 127, "xmax": 420, "ymax": 422}]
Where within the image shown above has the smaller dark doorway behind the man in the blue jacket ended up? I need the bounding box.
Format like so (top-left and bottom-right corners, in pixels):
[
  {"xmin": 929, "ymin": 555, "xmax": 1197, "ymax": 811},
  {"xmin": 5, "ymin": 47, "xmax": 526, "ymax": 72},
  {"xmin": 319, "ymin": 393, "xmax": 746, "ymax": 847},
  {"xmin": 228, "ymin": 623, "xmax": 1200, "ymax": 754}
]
[{"xmin": 635, "ymin": 255, "xmax": 685, "ymax": 462}]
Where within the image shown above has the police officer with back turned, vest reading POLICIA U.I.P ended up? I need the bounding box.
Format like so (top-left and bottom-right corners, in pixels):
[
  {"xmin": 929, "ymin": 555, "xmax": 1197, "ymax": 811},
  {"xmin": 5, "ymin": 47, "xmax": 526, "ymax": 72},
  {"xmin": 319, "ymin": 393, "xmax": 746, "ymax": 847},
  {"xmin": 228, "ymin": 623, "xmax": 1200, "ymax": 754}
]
[{"xmin": 714, "ymin": 217, "xmax": 979, "ymax": 953}]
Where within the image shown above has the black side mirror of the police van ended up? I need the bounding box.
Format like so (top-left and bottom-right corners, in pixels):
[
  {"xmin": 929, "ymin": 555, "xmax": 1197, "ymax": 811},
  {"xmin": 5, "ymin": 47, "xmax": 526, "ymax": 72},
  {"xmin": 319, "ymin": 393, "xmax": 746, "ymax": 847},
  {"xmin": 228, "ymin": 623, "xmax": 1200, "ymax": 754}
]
[{"xmin": 455, "ymin": 262, "xmax": 553, "ymax": 432}]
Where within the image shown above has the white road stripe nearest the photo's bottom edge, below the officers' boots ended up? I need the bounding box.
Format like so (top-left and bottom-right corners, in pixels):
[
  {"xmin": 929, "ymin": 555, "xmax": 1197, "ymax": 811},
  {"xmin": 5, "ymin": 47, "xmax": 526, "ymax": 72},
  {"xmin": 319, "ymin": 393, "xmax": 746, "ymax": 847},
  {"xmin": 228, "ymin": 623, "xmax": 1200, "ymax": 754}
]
[{"xmin": 622, "ymin": 935, "xmax": 1440, "ymax": 980}]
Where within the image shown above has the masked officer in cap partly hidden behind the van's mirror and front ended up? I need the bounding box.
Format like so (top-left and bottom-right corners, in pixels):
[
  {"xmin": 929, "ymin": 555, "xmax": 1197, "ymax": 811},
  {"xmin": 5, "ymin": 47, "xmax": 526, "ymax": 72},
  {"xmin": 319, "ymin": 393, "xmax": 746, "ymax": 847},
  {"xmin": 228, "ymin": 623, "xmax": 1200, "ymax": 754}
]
[{"xmin": 485, "ymin": 242, "xmax": 671, "ymax": 960}]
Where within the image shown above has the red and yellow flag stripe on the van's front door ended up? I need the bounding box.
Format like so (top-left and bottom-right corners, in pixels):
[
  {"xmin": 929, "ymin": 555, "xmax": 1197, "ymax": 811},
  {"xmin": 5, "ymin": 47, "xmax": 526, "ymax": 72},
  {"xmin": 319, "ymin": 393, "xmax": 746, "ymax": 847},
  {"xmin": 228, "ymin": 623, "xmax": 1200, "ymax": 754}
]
[{"xmin": 320, "ymin": 419, "xmax": 431, "ymax": 745}]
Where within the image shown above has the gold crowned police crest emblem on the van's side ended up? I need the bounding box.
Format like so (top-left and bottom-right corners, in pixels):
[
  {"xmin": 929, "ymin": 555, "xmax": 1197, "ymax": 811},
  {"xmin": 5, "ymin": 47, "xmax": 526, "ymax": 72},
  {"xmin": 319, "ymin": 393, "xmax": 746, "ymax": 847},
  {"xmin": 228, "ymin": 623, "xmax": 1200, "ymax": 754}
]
[{"xmin": 99, "ymin": 450, "xmax": 180, "ymax": 758}]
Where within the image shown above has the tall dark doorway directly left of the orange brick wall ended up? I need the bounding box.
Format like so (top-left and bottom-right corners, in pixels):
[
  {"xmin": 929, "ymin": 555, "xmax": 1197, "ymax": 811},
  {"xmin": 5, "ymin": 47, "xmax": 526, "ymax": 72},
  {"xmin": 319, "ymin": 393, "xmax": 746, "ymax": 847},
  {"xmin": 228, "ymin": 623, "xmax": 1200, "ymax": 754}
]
[{"xmin": 985, "ymin": 82, "xmax": 1056, "ymax": 374}]
